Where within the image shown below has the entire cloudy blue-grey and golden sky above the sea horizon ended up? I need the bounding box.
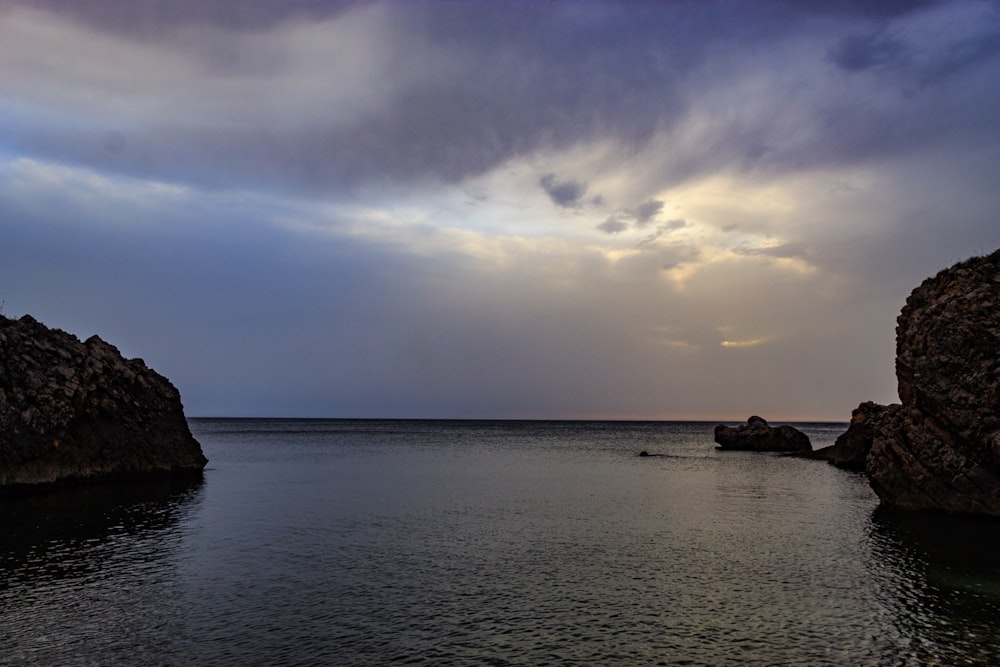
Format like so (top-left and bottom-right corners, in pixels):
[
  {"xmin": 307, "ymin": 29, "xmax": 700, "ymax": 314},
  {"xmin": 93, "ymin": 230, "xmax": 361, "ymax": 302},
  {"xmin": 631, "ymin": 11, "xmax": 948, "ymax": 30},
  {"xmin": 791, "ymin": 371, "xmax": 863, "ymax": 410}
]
[{"xmin": 0, "ymin": 0, "xmax": 1000, "ymax": 421}]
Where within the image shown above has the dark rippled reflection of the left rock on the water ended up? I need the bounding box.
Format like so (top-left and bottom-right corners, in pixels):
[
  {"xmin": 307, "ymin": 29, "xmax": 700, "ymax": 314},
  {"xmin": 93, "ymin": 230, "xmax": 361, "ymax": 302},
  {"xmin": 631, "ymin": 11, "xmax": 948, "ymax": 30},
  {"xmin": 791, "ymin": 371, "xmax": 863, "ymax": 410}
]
[{"xmin": 0, "ymin": 474, "xmax": 203, "ymax": 664}]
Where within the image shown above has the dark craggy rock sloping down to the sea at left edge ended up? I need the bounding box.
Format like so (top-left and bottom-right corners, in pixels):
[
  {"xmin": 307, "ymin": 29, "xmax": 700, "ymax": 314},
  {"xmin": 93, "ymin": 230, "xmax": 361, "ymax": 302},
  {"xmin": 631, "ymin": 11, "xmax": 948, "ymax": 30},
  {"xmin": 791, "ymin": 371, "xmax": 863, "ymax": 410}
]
[{"xmin": 0, "ymin": 315, "xmax": 207, "ymax": 490}]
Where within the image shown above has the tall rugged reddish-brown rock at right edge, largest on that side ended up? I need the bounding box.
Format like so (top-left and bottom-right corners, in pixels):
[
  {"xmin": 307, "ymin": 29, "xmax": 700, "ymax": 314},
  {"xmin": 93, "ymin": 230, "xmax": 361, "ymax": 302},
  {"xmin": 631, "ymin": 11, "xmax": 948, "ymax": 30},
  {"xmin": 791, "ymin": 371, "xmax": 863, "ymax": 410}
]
[{"xmin": 866, "ymin": 251, "xmax": 1000, "ymax": 516}]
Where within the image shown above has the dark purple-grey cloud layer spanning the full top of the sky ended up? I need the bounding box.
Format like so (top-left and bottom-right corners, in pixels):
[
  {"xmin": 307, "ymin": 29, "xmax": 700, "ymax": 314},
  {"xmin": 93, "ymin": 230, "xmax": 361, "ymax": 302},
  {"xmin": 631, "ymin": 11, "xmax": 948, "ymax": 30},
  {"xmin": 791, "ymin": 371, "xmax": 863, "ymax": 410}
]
[{"xmin": 0, "ymin": 0, "xmax": 1000, "ymax": 205}]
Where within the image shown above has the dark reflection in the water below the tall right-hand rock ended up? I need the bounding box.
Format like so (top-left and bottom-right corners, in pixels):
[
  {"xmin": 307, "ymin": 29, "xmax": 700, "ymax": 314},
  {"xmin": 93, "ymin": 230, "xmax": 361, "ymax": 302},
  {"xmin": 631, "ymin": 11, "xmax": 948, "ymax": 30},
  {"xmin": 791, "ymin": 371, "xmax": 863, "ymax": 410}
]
[{"xmin": 871, "ymin": 508, "xmax": 1000, "ymax": 665}]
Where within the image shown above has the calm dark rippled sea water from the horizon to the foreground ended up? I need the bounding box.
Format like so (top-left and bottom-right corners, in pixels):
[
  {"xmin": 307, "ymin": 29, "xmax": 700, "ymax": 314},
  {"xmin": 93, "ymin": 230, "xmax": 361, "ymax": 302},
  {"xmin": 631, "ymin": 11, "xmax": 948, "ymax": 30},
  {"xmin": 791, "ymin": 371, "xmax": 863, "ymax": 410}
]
[{"xmin": 0, "ymin": 420, "xmax": 1000, "ymax": 666}]
